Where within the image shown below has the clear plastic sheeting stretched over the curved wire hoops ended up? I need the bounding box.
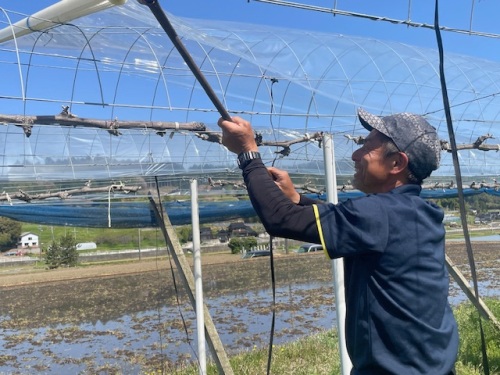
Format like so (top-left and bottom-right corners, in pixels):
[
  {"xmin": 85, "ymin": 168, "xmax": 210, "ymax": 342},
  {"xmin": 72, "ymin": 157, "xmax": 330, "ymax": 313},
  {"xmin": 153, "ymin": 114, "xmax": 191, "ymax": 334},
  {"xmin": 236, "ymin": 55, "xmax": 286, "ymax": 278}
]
[{"xmin": 0, "ymin": 1, "xmax": 500, "ymax": 180}]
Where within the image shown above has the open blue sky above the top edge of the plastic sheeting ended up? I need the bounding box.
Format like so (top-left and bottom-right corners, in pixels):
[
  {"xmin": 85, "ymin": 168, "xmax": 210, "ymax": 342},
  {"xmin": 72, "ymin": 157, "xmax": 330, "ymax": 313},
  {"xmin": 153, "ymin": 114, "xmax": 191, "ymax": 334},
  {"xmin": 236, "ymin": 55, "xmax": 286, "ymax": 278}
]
[{"xmin": 0, "ymin": 0, "xmax": 500, "ymax": 61}]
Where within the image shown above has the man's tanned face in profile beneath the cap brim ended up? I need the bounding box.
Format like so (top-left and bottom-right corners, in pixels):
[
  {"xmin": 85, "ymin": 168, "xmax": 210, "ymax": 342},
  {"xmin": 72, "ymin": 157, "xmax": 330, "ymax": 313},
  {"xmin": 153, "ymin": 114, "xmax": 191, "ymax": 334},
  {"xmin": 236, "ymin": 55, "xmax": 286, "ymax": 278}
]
[{"xmin": 352, "ymin": 129, "xmax": 393, "ymax": 194}]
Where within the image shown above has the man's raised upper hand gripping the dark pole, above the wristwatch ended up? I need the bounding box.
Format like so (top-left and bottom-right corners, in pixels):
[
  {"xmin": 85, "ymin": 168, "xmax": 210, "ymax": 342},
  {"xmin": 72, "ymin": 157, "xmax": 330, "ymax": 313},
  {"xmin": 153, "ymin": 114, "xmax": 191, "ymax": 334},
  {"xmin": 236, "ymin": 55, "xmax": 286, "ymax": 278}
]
[{"xmin": 218, "ymin": 117, "xmax": 259, "ymax": 154}]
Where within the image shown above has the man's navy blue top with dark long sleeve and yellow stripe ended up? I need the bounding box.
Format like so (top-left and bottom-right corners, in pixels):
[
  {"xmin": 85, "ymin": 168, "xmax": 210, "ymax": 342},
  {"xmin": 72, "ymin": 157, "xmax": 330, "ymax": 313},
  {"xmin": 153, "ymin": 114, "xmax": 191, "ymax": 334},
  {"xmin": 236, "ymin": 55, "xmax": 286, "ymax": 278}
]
[{"xmin": 243, "ymin": 160, "xmax": 458, "ymax": 375}]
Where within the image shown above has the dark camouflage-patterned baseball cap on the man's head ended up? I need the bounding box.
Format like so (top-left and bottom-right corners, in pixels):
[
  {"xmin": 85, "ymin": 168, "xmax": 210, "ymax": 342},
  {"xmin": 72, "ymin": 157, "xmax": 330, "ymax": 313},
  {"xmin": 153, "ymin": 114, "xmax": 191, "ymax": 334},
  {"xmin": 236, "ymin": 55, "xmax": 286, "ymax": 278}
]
[{"xmin": 358, "ymin": 108, "xmax": 441, "ymax": 180}]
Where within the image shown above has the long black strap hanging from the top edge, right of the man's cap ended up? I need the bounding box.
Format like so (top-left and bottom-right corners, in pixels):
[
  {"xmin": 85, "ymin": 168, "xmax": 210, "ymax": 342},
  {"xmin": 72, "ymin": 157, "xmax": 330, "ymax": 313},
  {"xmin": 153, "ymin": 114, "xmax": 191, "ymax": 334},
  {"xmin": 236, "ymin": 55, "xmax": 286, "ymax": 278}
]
[{"xmin": 434, "ymin": 0, "xmax": 490, "ymax": 375}]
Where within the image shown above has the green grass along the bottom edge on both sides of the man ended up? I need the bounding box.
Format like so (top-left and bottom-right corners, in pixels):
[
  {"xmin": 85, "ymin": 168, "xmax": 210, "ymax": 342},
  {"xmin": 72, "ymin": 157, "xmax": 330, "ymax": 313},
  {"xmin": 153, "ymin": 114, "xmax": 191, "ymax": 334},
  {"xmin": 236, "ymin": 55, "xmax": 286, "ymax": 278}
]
[{"xmin": 148, "ymin": 299, "xmax": 500, "ymax": 375}]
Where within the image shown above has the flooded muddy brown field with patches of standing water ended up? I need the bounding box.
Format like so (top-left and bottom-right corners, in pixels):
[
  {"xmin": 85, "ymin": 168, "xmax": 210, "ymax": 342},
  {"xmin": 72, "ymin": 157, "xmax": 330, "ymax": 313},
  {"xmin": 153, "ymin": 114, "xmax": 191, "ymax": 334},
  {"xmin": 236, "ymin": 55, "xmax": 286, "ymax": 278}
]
[{"xmin": 0, "ymin": 243, "xmax": 500, "ymax": 374}]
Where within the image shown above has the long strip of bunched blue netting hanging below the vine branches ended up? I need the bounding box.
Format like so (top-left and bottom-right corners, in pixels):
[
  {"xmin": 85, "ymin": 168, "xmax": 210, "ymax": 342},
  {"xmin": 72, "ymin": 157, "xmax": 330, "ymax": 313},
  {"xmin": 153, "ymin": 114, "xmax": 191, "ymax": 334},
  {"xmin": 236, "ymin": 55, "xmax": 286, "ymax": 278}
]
[{"xmin": 0, "ymin": 188, "xmax": 494, "ymax": 229}]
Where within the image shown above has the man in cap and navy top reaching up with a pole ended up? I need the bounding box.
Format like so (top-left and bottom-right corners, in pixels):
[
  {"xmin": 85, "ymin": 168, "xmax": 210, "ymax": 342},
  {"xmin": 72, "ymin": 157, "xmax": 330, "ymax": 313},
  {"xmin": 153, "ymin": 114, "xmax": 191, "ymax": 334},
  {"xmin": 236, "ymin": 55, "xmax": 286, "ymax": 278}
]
[{"xmin": 219, "ymin": 109, "xmax": 458, "ymax": 375}]
